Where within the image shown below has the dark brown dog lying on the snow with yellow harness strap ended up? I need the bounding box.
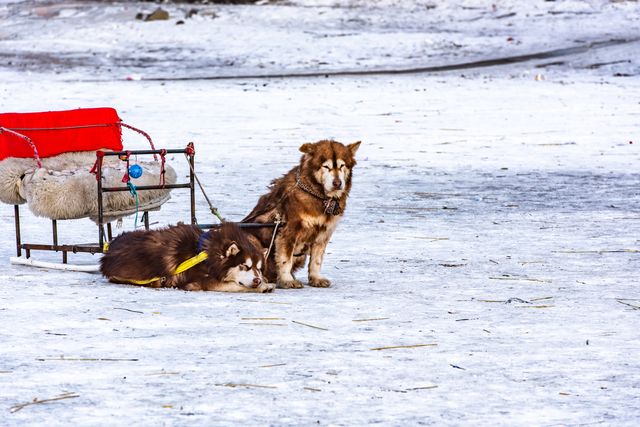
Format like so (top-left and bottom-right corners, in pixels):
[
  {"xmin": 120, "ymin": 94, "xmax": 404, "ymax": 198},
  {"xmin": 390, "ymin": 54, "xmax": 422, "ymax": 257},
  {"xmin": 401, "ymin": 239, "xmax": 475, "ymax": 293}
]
[{"xmin": 100, "ymin": 223, "xmax": 275, "ymax": 292}]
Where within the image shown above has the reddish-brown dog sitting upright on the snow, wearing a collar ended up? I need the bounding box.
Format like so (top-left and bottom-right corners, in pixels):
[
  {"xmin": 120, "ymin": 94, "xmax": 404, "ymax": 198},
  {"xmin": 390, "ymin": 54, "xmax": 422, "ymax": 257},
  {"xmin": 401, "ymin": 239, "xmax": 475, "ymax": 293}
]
[{"xmin": 242, "ymin": 140, "xmax": 360, "ymax": 288}]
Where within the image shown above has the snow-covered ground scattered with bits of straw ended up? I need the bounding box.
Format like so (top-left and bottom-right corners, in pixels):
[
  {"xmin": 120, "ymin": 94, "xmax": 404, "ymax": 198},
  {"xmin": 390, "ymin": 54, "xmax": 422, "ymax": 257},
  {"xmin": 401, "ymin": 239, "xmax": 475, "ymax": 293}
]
[{"xmin": 0, "ymin": 1, "xmax": 640, "ymax": 426}]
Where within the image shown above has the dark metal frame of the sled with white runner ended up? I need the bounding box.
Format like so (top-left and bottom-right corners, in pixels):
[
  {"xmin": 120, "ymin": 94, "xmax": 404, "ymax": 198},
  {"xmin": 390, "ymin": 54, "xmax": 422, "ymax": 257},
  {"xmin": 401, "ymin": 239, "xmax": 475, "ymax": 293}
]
[{"xmin": 10, "ymin": 143, "xmax": 275, "ymax": 272}]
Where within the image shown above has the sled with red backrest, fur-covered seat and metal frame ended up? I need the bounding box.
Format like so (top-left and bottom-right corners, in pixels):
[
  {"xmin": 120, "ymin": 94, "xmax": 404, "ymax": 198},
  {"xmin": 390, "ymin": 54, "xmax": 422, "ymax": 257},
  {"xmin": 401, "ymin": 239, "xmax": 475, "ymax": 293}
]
[{"xmin": 0, "ymin": 108, "xmax": 196, "ymax": 271}]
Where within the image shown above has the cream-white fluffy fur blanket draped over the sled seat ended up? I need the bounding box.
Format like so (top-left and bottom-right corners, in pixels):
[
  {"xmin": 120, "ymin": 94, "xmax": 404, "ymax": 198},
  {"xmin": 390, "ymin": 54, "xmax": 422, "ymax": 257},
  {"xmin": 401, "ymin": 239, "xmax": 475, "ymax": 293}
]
[{"xmin": 0, "ymin": 151, "xmax": 176, "ymax": 222}]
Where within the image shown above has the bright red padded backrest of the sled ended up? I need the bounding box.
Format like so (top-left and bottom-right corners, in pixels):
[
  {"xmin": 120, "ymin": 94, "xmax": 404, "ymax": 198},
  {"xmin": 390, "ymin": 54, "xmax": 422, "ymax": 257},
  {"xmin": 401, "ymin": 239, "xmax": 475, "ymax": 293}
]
[{"xmin": 0, "ymin": 108, "xmax": 122, "ymax": 160}]
